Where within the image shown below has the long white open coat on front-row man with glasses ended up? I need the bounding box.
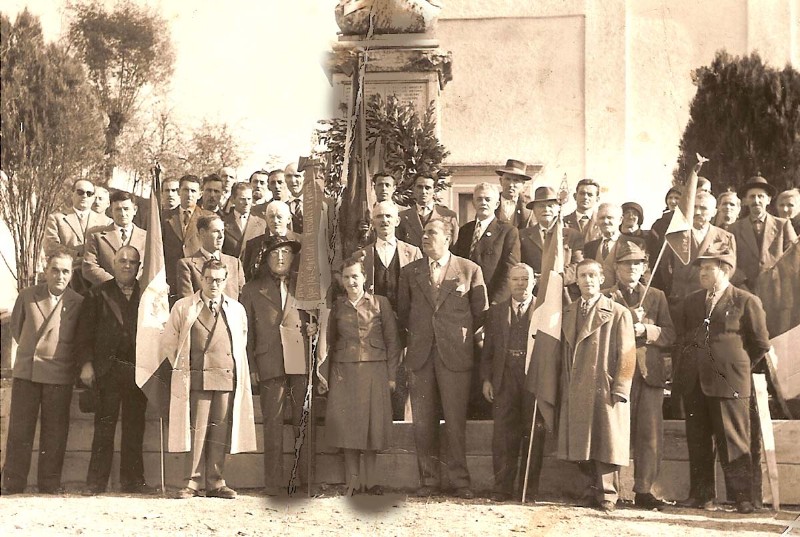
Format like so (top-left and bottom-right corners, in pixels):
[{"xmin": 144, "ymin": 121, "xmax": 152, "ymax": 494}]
[{"xmin": 161, "ymin": 291, "xmax": 256, "ymax": 453}]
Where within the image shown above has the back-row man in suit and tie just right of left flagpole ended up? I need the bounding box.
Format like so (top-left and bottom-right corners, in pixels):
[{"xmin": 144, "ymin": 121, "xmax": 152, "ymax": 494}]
[{"xmin": 162, "ymin": 175, "xmax": 214, "ymax": 300}]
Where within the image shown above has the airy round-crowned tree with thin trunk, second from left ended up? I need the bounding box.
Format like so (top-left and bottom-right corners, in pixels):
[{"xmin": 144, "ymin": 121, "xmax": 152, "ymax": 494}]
[{"xmin": 68, "ymin": 0, "xmax": 174, "ymax": 179}]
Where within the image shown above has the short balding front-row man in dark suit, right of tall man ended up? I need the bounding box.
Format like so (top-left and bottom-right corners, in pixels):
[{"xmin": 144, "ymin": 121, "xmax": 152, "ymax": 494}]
[{"xmin": 481, "ymin": 263, "xmax": 546, "ymax": 502}]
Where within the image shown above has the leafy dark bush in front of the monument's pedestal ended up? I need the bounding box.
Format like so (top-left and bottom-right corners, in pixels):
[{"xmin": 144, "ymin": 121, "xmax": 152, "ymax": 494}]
[{"xmin": 317, "ymin": 95, "xmax": 450, "ymax": 205}]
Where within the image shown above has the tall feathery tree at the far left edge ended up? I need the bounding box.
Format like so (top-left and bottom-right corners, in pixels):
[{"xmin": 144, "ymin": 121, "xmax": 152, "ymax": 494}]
[{"xmin": 0, "ymin": 10, "xmax": 103, "ymax": 287}]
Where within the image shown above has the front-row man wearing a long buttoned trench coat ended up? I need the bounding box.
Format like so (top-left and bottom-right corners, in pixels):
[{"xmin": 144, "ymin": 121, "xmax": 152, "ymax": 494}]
[{"xmin": 558, "ymin": 259, "xmax": 636, "ymax": 512}]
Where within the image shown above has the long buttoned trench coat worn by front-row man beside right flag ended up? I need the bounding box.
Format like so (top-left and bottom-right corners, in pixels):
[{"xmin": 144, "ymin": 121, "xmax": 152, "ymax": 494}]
[{"xmin": 558, "ymin": 296, "xmax": 636, "ymax": 466}]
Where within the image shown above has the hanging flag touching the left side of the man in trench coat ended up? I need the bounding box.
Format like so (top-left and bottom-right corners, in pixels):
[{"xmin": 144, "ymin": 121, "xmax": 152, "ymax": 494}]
[{"xmin": 525, "ymin": 218, "xmax": 564, "ymax": 431}]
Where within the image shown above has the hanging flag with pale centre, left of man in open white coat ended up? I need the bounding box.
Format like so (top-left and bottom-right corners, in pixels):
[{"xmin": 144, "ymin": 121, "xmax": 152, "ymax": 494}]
[{"xmin": 136, "ymin": 176, "xmax": 172, "ymax": 418}]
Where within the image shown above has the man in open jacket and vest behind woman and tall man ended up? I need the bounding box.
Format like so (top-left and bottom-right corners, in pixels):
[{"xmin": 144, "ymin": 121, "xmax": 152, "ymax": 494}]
[{"xmin": 354, "ymin": 199, "xmax": 422, "ymax": 421}]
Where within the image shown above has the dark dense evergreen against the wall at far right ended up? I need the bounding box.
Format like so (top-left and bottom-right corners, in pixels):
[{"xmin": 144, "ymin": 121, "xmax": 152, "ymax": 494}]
[{"xmin": 675, "ymin": 51, "xmax": 800, "ymax": 192}]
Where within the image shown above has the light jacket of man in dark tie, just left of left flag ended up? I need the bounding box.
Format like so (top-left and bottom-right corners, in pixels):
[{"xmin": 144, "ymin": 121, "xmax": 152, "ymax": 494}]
[{"xmin": 81, "ymin": 223, "xmax": 147, "ymax": 286}]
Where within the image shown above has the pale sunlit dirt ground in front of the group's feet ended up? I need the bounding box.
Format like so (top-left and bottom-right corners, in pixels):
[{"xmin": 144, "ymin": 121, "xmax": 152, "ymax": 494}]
[{"xmin": 0, "ymin": 491, "xmax": 800, "ymax": 537}]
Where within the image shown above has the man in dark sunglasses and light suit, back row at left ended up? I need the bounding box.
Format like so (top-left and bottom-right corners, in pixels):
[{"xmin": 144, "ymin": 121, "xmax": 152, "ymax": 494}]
[{"xmin": 44, "ymin": 179, "xmax": 112, "ymax": 293}]
